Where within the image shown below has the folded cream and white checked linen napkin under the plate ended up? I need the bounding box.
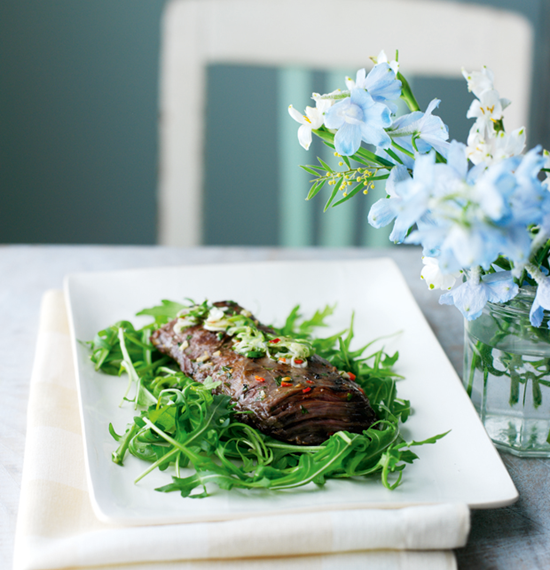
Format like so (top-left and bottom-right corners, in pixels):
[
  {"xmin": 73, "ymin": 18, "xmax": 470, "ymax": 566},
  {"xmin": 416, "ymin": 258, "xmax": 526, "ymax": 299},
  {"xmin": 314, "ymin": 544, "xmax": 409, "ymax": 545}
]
[{"xmin": 14, "ymin": 291, "xmax": 470, "ymax": 570}]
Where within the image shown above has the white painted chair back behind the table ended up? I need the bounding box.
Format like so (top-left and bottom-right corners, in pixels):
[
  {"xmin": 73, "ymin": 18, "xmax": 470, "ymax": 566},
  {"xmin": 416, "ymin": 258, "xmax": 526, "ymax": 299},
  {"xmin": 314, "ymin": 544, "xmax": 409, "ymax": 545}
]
[{"xmin": 158, "ymin": 0, "xmax": 533, "ymax": 246}]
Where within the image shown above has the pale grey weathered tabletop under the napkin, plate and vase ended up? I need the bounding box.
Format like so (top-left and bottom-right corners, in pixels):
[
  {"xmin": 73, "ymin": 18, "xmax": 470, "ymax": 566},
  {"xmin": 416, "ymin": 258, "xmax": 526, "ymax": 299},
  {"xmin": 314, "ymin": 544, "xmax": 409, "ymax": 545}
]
[{"xmin": 0, "ymin": 245, "xmax": 550, "ymax": 570}]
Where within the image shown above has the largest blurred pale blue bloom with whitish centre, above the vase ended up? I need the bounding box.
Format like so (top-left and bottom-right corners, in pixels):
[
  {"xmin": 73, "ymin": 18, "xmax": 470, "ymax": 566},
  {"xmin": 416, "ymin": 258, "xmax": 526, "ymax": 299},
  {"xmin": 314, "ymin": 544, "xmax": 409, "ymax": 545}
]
[{"xmin": 406, "ymin": 141, "xmax": 550, "ymax": 271}]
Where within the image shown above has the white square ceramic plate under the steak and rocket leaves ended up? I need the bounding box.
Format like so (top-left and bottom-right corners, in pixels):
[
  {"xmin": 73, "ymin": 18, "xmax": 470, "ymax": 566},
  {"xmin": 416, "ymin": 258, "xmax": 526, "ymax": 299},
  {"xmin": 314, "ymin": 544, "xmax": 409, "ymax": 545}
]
[{"xmin": 65, "ymin": 259, "xmax": 518, "ymax": 524}]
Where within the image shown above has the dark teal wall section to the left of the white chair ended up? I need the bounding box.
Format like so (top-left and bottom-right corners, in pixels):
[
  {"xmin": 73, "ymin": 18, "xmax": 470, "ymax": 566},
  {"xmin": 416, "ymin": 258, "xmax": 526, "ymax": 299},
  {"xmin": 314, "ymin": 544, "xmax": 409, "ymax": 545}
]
[{"xmin": 0, "ymin": 0, "xmax": 164, "ymax": 244}]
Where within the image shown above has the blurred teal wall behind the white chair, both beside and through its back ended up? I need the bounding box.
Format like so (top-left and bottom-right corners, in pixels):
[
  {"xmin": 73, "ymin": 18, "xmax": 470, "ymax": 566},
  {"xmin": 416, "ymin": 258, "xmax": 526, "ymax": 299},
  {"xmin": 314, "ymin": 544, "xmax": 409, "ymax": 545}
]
[{"xmin": 0, "ymin": 0, "xmax": 550, "ymax": 245}]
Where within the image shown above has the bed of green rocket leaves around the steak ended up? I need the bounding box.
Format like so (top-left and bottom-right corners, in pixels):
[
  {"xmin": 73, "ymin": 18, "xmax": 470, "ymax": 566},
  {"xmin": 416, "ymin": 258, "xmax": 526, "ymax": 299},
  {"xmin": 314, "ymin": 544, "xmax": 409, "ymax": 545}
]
[{"xmin": 86, "ymin": 301, "xmax": 445, "ymax": 498}]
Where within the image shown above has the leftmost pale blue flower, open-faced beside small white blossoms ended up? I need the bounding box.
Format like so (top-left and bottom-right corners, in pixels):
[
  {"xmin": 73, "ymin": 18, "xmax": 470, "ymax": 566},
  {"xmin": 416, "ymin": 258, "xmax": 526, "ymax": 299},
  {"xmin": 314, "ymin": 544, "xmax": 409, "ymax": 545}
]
[{"xmin": 325, "ymin": 89, "xmax": 391, "ymax": 156}]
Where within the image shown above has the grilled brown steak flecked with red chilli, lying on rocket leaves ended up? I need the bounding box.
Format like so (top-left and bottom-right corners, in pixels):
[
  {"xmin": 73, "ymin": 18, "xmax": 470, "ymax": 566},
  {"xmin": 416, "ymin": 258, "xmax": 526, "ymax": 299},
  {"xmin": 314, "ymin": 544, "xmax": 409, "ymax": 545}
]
[{"xmin": 151, "ymin": 301, "xmax": 377, "ymax": 445}]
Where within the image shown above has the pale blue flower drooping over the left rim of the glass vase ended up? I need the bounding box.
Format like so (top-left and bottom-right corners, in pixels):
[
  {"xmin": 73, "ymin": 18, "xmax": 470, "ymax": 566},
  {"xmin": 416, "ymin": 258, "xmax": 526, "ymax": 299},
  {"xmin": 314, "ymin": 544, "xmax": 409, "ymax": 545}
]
[{"xmin": 439, "ymin": 270, "xmax": 519, "ymax": 321}]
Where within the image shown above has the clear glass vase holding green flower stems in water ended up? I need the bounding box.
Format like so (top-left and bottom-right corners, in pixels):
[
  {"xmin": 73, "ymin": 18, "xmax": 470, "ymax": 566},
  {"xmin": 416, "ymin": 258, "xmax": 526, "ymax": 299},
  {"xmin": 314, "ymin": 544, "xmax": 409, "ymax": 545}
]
[{"xmin": 464, "ymin": 288, "xmax": 550, "ymax": 457}]
